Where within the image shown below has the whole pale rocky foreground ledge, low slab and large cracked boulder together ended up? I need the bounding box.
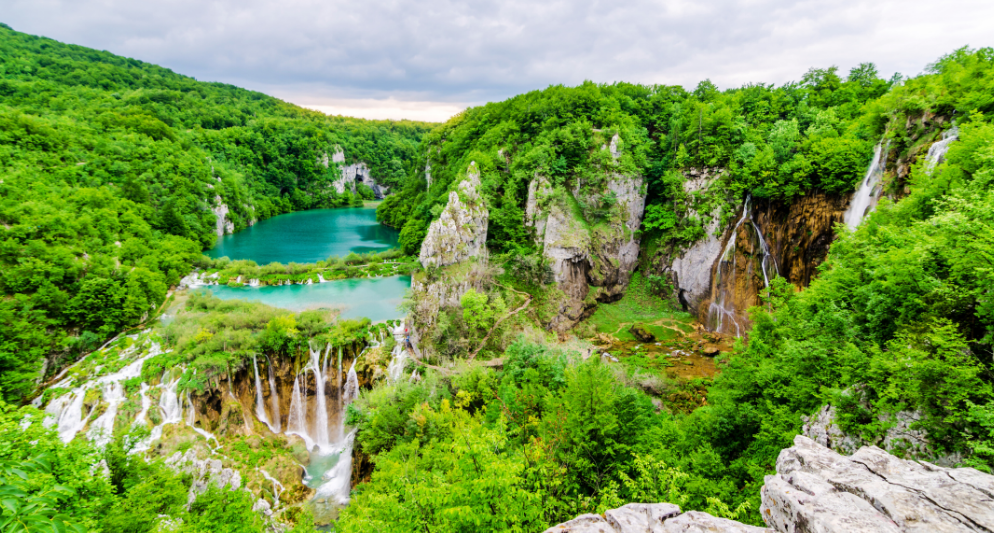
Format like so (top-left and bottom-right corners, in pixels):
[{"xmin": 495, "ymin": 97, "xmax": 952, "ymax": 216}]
[{"xmin": 546, "ymin": 435, "xmax": 994, "ymax": 533}]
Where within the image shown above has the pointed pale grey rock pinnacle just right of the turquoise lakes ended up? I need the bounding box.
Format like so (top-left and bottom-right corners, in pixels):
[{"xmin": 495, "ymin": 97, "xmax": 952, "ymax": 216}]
[{"xmin": 418, "ymin": 162, "xmax": 490, "ymax": 268}]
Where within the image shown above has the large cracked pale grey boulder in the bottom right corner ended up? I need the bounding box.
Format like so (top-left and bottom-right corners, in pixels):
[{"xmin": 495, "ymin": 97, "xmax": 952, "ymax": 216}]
[{"xmin": 761, "ymin": 435, "xmax": 994, "ymax": 533}]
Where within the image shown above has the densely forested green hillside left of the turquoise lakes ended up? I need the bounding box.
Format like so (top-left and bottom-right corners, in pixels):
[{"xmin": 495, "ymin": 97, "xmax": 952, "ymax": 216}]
[{"xmin": 0, "ymin": 26, "xmax": 429, "ymax": 401}]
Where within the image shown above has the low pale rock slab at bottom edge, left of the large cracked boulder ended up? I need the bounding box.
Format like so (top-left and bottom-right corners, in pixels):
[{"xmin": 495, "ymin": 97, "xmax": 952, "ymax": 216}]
[{"xmin": 545, "ymin": 503, "xmax": 771, "ymax": 533}]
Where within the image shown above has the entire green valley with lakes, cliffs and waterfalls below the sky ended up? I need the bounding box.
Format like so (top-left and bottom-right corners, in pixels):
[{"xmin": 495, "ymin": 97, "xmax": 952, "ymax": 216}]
[{"xmin": 0, "ymin": 22, "xmax": 994, "ymax": 533}]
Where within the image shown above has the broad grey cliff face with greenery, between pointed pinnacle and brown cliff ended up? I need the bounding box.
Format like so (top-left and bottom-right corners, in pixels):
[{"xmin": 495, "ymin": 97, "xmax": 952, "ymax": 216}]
[{"xmin": 525, "ymin": 135, "xmax": 645, "ymax": 331}]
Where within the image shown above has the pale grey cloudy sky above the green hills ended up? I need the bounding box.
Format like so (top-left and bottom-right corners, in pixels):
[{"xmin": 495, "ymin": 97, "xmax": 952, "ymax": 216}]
[{"xmin": 0, "ymin": 0, "xmax": 994, "ymax": 121}]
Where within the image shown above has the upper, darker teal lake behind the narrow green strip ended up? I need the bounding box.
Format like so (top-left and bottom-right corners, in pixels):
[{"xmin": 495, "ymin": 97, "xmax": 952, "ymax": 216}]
[{"xmin": 206, "ymin": 207, "xmax": 400, "ymax": 265}]
